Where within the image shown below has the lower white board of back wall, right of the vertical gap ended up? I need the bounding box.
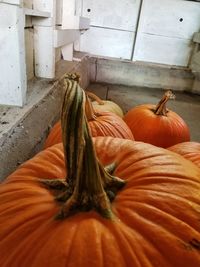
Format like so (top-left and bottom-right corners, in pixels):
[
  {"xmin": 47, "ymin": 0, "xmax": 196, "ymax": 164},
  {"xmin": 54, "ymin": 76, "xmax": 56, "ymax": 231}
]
[{"xmin": 135, "ymin": 34, "xmax": 192, "ymax": 66}]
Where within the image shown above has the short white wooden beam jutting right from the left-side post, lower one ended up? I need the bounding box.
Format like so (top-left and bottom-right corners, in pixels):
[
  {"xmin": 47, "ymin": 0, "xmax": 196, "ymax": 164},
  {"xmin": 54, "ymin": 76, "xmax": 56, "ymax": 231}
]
[{"xmin": 54, "ymin": 29, "xmax": 80, "ymax": 47}]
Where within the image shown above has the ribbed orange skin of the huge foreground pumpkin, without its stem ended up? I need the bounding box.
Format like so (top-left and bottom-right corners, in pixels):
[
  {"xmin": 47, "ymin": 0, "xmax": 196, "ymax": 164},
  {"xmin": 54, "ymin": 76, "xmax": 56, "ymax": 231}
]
[{"xmin": 0, "ymin": 137, "xmax": 200, "ymax": 267}]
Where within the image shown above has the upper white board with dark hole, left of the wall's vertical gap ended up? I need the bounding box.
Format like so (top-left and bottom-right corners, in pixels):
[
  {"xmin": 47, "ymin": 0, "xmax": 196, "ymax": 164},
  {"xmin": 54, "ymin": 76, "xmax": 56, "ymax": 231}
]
[{"xmin": 79, "ymin": 0, "xmax": 141, "ymax": 31}]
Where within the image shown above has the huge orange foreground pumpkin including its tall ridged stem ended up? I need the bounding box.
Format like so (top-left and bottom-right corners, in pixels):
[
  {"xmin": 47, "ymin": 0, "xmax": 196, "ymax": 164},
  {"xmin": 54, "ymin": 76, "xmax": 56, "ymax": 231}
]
[{"xmin": 0, "ymin": 76, "xmax": 200, "ymax": 267}]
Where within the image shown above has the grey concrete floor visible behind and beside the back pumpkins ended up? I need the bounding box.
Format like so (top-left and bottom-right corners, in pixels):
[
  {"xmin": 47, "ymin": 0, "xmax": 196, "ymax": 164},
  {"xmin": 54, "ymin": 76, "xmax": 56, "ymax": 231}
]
[{"xmin": 88, "ymin": 83, "xmax": 200, "ymax": 142}]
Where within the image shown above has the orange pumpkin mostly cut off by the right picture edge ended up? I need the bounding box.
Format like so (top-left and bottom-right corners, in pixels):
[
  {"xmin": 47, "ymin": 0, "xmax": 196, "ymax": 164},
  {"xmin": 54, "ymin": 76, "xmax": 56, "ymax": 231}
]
[{"xmin": 168, "ymin": 142, "xmax": 200, "ymax": 167}]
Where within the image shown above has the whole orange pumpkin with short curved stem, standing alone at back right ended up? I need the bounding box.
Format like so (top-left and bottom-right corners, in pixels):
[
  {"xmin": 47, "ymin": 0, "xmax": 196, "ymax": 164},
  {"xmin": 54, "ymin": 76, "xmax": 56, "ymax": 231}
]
[{"xmin": 124, "ymin": 91, "xmax": 190, "ymax": 148}]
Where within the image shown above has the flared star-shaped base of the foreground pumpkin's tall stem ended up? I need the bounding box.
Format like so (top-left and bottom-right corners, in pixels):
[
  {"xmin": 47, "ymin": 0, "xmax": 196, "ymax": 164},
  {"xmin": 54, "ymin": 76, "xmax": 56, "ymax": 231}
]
[{"xmin": 40, "ymin": 164, "xmax": 125, "ymax": 219}]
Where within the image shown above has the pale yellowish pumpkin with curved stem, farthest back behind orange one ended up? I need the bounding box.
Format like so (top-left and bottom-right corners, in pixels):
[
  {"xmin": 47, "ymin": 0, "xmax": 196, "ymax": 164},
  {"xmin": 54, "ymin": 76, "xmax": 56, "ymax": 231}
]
[{"xmin": 86, "ymin": 91, "xmax": 124, "ymax": 118}]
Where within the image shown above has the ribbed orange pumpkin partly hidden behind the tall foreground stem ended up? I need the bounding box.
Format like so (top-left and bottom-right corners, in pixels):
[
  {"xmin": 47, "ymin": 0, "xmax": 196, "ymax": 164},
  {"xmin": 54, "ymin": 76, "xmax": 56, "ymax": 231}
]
[{"xmin": 45, "ymin": 112, "xmax": 134, "ymax": 148}]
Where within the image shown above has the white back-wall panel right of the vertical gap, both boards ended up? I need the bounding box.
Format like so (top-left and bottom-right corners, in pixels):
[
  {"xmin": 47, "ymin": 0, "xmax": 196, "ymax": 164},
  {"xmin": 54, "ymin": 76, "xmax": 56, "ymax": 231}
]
[{"xmin": 133, "ymin": 0, "xmax": 200, "ymax": 66}]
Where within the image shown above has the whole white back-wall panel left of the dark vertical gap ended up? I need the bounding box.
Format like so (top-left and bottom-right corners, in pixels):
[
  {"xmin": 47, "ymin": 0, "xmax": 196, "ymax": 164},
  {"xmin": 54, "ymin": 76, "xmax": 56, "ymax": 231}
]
[{"xmin": 75, "ymin": 0, "xmax": 141, "ymax": 59}]
